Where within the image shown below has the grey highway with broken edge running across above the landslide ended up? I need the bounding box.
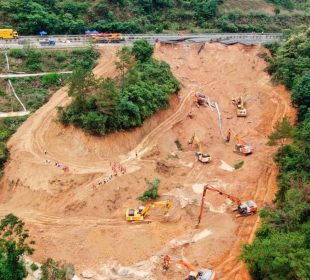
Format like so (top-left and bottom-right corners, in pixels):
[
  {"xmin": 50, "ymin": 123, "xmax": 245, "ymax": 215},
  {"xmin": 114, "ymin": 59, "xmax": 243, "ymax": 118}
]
[{"xmin": 0, "ymin": 33, "xmax": 282, "ymax": 49}]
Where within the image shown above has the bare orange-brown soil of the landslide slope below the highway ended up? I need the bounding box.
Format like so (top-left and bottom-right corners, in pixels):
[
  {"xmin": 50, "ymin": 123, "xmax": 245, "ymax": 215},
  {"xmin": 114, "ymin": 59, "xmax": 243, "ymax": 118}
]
[{"xmin": 0, "ymin": 44, "xmax": 295, "ymax": 280}]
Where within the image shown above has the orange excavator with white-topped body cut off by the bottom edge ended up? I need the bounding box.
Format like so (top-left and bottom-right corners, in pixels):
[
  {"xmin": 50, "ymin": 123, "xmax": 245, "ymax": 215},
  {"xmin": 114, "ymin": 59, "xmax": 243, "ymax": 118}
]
[{"xmin": 163, "ymin": 255, "xmax": 216, "ymax": 280}]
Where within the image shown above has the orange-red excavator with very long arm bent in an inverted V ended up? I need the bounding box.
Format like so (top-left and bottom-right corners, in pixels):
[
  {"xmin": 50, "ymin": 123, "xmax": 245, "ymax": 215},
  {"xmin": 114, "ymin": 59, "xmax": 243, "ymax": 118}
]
[{"xmin": 197, "ymin": 185, "xmax": 257, "ymax": 227}]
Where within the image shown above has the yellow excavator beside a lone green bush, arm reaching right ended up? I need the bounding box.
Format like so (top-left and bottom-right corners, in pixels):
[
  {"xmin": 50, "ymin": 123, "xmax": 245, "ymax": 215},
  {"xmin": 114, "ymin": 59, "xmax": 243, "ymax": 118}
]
[{"xmin": 126, "ymin": 200, "xmax": 173, "ymax": 221}]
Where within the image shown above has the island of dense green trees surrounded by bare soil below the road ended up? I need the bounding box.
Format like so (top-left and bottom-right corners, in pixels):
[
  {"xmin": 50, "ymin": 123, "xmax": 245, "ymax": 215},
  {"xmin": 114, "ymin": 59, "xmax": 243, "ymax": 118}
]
[{"xmin": 59, "ymin": 40, "xmax": 179, "ymax": 135}]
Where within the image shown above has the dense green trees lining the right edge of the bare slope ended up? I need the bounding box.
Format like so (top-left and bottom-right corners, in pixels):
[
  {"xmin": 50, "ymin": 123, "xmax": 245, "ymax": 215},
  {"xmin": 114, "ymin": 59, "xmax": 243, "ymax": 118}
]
[{"xmin": 242, "ymin": 28, "xmax": 310, "ymax": 280}]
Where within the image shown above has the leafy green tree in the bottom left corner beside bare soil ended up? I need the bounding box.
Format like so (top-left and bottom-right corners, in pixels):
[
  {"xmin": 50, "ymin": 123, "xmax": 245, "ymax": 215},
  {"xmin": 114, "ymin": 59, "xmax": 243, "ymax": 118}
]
[{"xmin": 0, "ymin": 214, "xmax": 34, "ymax": 280}]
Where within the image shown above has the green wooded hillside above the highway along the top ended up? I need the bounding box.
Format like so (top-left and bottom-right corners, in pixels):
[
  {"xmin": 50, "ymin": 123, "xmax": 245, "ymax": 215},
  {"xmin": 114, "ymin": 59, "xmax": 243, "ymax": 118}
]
[{"xmin": 0, "ymin": 0, "xmax": 310, "ymax": 35}]
